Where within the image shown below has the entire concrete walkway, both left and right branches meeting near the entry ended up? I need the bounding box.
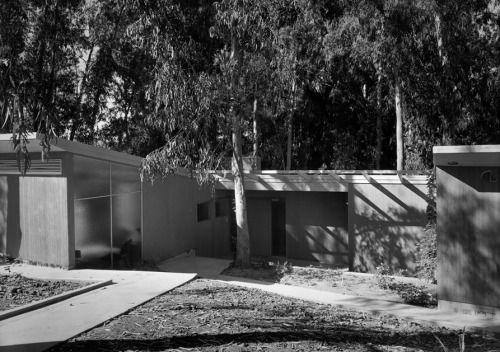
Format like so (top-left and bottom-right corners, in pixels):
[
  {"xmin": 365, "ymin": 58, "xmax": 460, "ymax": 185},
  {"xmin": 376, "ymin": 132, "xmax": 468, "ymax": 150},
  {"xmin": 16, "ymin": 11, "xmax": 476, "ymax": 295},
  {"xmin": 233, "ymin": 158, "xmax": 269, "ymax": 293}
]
[{"xmin": 0, "ymin": 257, "xmax": 500, "ymax": 352}]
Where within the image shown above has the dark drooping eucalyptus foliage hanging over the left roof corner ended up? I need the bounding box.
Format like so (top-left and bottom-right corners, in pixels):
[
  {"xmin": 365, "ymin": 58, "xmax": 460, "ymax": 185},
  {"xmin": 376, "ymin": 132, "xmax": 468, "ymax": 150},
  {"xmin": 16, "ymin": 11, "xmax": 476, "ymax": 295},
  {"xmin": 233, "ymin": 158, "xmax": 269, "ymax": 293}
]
[{"xmin": 0, "ymin": 0, "xmax": 87, "ymax": 172}]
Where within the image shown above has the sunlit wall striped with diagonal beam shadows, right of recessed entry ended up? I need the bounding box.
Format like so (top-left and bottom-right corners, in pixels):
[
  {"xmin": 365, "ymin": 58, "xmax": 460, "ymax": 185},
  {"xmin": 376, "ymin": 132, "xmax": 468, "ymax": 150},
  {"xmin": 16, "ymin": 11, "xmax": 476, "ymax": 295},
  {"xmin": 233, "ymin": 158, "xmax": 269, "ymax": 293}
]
[{"xmin": 349, "ymin": 181, "xmax": 427, "ymax": 272}]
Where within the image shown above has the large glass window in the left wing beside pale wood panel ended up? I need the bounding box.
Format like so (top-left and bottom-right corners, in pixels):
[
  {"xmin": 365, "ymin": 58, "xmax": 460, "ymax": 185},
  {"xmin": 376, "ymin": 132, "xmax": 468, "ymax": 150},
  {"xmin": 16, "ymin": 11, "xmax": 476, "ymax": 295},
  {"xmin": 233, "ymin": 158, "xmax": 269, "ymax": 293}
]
[{"xmin": 73, "ymin": 156, "xmax": 142, "ymax": 268}]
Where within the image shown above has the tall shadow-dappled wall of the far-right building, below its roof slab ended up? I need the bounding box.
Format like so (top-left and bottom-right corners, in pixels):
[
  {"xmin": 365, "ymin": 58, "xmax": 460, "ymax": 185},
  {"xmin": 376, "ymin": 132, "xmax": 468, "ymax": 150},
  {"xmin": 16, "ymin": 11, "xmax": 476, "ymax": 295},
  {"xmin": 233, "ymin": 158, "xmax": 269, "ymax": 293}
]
[{"xmin": 436, "ymin": 166, "xmax": 500, "ymax": 315}]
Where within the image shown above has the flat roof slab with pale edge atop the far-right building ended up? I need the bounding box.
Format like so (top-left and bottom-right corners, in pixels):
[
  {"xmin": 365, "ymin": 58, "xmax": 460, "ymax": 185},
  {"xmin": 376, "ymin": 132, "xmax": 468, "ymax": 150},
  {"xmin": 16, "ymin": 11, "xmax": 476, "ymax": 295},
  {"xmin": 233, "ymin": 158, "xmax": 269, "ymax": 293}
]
[{"xmin": 432, "ymin": 144, "xmax": 500, "ymax": 166}]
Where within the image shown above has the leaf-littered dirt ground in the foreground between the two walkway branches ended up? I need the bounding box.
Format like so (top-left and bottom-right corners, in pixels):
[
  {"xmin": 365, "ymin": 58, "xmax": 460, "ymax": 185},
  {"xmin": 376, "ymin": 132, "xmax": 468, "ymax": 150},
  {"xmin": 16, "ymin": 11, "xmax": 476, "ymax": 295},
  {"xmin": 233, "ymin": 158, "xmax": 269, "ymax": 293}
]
[{"xmin": 50, "ymin": 279, "xmax": 500, "ymax": 352}]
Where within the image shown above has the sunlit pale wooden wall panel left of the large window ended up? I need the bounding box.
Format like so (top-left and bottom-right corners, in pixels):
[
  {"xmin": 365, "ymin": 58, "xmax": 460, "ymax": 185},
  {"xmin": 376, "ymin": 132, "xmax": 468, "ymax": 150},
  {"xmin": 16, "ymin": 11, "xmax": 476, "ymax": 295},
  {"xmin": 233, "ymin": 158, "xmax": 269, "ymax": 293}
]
[{"xmin": 19, "ymin": 177, "xmax": 70, "ymax": 268}]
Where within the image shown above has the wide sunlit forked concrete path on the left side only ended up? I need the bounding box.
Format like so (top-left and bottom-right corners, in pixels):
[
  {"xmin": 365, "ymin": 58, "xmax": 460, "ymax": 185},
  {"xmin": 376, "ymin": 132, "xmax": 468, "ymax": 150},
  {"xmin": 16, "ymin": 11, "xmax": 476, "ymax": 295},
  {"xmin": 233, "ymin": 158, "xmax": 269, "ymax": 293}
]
[{"xmin": 0, "ymin": 264, "xmax": 196, "ymax": 352}]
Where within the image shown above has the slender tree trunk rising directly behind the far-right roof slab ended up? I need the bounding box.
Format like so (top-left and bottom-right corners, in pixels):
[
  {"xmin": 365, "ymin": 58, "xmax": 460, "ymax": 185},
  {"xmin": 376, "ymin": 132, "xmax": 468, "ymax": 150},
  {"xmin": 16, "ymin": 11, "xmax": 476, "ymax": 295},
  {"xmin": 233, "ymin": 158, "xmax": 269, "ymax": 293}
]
[{"xmin": 434, "ymin": 8, "xmax": 456, "ymax": 145}]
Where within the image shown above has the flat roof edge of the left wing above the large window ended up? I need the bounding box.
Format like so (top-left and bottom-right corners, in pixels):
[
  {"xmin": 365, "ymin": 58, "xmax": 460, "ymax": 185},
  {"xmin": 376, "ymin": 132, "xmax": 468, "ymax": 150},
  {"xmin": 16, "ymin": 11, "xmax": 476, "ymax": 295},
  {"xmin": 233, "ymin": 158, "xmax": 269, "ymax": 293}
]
[{"xmin": 0, "ymin": 133, "xmax": 142, "ymax": 167}]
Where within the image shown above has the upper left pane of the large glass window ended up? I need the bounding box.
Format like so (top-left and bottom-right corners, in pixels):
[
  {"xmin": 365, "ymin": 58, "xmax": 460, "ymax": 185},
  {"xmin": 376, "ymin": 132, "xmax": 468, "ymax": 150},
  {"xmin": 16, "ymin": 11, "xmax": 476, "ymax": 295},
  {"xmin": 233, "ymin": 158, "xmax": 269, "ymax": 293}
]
[{"xmin": 73, "ymin": 156, "xmax": 110, "ymax": 199}]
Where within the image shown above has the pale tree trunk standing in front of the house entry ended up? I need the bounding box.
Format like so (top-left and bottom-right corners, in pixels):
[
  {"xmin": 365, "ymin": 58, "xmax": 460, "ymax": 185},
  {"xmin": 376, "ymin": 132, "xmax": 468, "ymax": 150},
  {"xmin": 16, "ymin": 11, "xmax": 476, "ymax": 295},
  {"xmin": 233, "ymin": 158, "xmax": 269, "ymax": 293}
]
[{"xmin": 229, "ymin": 28, "xmax": 251, "ymax": 268}]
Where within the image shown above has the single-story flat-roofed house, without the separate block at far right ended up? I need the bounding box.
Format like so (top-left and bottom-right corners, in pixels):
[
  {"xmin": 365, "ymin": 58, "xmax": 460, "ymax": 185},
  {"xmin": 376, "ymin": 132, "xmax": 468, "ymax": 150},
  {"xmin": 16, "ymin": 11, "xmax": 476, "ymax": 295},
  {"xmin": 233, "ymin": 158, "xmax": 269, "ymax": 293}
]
[{"xmin": 0, "ymin": 134, "xmax": 427, "ymax": 272}]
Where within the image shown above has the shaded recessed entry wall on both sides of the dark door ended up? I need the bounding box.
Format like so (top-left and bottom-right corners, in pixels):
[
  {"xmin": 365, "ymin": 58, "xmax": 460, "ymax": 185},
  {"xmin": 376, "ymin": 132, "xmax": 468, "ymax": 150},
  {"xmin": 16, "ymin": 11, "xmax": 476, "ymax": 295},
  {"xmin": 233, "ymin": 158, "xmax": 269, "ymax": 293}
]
[{"xmin": 221, "ymin": 191, "xmax": 348, "ymax": 265}]
